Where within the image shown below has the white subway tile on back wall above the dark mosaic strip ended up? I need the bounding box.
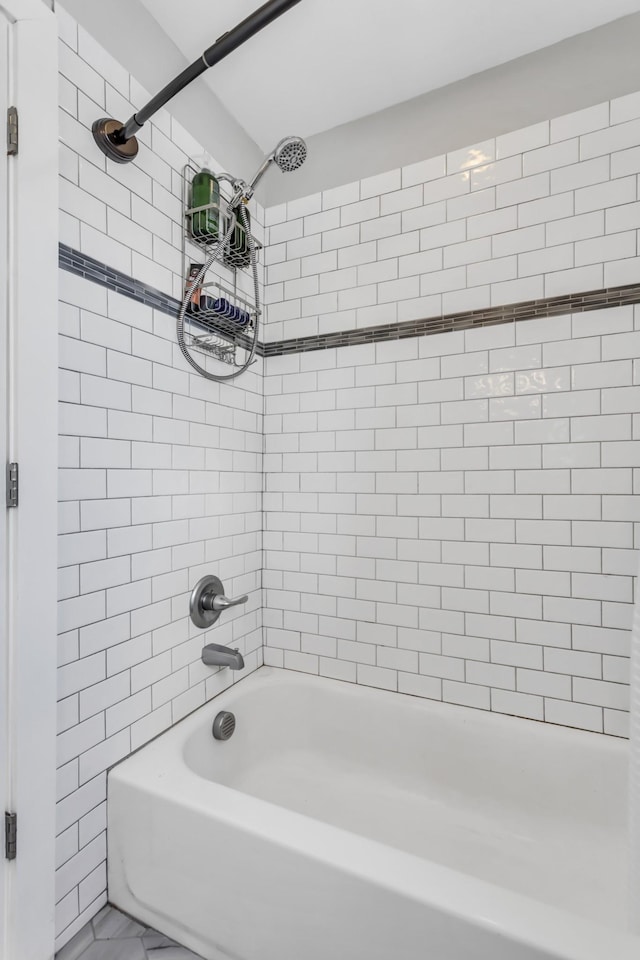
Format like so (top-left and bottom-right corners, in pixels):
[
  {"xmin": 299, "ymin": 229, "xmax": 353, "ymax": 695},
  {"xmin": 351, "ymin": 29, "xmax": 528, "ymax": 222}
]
[{"xmin": 266, "ymin": 96, "xmax": 640, "ymax": 340}]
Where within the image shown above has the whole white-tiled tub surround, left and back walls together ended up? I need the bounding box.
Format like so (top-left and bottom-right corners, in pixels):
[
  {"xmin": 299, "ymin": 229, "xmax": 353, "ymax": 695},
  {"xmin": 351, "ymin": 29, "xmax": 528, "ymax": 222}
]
[{"xmin": 52, "ymin": 7, "xmax": 640, "ymax": 947}]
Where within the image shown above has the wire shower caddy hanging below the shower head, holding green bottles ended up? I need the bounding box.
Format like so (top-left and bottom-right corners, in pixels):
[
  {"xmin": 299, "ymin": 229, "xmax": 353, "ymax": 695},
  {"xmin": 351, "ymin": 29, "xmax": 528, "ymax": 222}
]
[{"xmin": 182, "ymin": 163, "xmax": 262, "ymax": 368}]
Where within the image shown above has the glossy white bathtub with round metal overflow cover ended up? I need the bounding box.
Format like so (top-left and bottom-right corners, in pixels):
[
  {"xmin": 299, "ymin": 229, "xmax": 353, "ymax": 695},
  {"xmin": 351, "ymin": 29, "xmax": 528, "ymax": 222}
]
[{"xmin": 108, "ymin": 668, "xmax": 640, "ymax": 960}]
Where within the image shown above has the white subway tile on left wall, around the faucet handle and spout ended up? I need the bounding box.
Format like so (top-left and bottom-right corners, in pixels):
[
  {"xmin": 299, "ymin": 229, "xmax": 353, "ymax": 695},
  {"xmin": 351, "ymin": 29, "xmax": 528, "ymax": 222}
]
[{"xmin": 56, "ymin": 7, "xmax": 263, "ymax": 947}]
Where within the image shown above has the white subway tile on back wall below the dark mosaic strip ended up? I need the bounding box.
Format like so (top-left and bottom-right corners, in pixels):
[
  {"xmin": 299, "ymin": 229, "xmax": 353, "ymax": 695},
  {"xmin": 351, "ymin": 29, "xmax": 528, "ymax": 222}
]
[{"xmin": 263, "ymin": 306, "xmax": 640, "ymax": 736}]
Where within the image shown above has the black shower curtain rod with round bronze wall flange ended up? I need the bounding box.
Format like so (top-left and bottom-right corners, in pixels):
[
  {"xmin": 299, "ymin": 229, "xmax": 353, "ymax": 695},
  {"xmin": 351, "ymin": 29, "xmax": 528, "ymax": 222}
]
[{"xmin": 92, "ymin": 0, "xmax": 300, "ymax": 163}]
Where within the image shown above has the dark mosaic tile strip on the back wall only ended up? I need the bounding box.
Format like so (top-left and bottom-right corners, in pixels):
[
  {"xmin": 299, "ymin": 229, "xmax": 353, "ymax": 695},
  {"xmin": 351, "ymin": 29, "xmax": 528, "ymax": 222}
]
[{"xmin": 262, "ymin": 283, "xmax": 640, "ymax": 357}]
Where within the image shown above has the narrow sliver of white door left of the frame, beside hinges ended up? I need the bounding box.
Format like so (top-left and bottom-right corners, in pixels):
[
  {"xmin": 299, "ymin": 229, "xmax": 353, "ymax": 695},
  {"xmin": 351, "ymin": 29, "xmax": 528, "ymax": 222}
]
[{"xmin": 0, "ymin": 13, "xmax": 10, "ymax": 957}]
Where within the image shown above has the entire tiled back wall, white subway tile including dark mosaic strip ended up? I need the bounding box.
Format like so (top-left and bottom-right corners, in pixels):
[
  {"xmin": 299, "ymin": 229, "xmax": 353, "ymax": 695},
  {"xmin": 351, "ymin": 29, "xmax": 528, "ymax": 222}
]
[{"xmin": 264, "ymin": 86, "xmax": 640, "ymax": 736}]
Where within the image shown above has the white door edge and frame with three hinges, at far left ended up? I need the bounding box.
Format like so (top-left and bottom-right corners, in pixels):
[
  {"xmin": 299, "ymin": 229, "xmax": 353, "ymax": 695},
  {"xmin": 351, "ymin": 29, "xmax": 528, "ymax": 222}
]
[{"xmin": 0, "ymin": 0, "xmax": 58, "ymax": 960}]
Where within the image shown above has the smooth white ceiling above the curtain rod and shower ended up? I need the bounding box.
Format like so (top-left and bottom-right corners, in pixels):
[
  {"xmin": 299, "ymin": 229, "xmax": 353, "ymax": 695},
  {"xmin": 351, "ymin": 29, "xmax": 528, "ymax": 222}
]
[{"xmin": 142, "ymin": 0, "xmax": 640, "ymax": 150}]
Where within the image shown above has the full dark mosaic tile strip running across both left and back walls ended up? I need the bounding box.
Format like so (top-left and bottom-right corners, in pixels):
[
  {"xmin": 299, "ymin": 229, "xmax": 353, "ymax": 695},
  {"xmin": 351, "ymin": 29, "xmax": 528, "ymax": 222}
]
[{"xmin": 59, "ymin": 243, "xmax": 640, "ymax": 357}]
